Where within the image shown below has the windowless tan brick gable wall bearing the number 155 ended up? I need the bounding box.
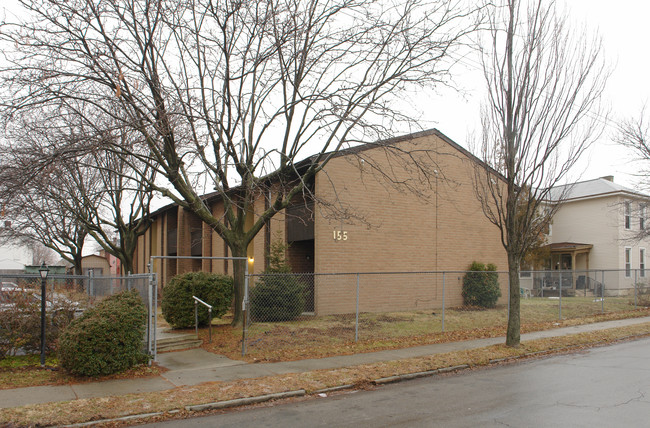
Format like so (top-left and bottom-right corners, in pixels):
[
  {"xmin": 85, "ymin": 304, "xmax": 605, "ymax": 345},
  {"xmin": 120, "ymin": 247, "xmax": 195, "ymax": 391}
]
[{"xmin": 315, "ymin": 135, "xmax": 507, "ymax": 315}]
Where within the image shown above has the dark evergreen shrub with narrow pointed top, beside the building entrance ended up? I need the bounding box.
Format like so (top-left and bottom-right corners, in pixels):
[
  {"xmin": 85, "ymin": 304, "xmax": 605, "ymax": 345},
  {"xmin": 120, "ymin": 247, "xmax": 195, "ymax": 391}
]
[{"xmin": 250, "ymin": 237, "xmax": 305, "ymax": 321}]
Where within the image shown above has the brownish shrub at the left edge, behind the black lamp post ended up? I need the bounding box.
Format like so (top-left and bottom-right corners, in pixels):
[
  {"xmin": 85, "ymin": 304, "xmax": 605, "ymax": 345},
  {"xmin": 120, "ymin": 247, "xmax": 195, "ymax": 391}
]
[{"xmin": 0, "ymin": 289, "xmax": 74, "ymax": 358}]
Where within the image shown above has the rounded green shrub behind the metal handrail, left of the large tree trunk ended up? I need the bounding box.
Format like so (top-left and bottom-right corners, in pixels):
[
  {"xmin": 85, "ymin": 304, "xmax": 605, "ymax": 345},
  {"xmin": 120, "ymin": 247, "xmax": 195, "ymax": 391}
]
[{"xmin": 160, "ymin": 272, "xmax": 233, "ymax": 328}]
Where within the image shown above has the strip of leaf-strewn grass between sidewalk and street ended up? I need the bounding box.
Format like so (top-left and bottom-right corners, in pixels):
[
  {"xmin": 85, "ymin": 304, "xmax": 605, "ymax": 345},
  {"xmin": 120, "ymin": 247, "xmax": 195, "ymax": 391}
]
[{"xmin": 0, "ymin": 323, "xmax": 650, "ymax": 426}]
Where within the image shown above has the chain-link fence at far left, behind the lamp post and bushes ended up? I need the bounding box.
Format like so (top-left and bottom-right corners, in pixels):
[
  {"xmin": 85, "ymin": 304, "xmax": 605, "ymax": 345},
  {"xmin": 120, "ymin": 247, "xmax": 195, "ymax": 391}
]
[{"xmin": 0, "ymin": 272, "xmax": 158, "ymax": 359}]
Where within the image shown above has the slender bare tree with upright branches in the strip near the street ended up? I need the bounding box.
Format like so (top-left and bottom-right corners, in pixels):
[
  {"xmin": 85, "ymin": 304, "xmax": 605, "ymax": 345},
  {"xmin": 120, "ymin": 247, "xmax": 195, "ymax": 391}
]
[{"xmin": 475, "ymin": 0, "xmax": 608, "ymax": 346}]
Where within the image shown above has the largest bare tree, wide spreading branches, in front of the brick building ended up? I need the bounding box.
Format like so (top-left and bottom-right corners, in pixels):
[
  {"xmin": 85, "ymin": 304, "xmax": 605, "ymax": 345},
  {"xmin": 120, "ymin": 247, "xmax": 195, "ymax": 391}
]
[{"xmin": 0, "ymin": 0, "xmax": 476, "ymax": 324}]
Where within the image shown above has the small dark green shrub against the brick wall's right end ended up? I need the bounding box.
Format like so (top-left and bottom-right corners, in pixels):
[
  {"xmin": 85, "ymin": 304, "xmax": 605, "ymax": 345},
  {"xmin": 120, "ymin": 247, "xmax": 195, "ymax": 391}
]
[{"xmin": 463, "ymin": 262, "xmax": 501, "ymax": 308}]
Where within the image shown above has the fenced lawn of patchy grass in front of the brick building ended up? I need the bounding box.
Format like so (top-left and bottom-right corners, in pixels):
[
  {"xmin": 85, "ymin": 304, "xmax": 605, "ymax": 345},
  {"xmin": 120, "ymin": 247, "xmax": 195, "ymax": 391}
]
[{"xmin": 199, "ymin": 297, "xmax": 650, "ymax": 362}]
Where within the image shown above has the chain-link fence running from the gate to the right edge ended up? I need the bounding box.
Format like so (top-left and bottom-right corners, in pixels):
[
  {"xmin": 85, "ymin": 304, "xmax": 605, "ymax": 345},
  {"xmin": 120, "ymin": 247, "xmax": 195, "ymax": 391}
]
[{"xmin": 243, "ymin": 269, "xmax": 650, "ymax": 354}]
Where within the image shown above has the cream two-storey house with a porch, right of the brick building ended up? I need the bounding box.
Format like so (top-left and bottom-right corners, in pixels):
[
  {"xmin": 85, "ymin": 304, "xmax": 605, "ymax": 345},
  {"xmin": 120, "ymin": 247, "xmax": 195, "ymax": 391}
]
[{"xmin": 536, "ymin": 176, "xmax": 650, "ymax": 295}]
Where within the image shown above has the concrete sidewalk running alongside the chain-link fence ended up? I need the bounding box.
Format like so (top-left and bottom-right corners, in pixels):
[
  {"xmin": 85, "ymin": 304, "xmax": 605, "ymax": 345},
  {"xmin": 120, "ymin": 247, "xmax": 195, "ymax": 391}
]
[{"xmin": 0, "ymin": 317, "xmax": 650, "ymax": 408}]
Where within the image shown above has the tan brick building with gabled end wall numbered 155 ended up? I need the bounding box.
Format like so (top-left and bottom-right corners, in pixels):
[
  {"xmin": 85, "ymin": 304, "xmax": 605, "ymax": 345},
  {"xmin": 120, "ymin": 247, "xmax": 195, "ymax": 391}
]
[{"xmin": 135, "ymin": 129, "xmax": 507, "ymax": 315}]
